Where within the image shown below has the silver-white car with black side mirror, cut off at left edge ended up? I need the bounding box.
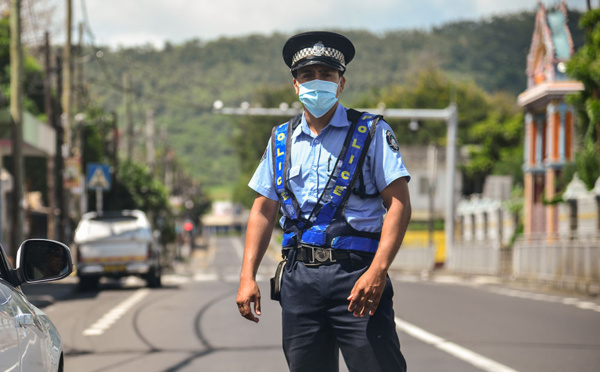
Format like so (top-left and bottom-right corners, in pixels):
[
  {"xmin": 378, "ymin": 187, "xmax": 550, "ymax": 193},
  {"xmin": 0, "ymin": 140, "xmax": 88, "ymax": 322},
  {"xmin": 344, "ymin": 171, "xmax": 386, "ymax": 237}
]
[{"xmin": 0, "ymin": 239, "xmax": 73, "ymax": 372}]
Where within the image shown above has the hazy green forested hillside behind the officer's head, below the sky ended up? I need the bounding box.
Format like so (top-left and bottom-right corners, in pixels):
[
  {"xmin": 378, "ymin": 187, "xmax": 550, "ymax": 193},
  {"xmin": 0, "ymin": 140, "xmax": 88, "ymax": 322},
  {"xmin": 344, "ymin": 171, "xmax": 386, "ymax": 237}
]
[{"xmin": 77, "ymin": 12, "xmax": 583, "ymax": 190}]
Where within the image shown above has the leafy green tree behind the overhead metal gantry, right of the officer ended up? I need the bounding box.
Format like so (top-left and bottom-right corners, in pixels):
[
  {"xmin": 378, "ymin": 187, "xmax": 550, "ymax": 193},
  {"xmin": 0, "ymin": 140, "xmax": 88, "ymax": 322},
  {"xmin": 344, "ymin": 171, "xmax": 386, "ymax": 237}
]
[{"xmin": 361, "ymin": 65, "xmax": 523, "ymax": 195}]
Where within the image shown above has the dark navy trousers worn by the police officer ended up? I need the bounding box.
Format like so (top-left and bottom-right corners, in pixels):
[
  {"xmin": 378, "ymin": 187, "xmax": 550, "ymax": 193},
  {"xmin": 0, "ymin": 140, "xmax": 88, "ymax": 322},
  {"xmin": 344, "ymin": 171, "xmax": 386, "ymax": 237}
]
[{"xmin": 281, "ymin": 253, "xmax": 406, "ymax": 372}]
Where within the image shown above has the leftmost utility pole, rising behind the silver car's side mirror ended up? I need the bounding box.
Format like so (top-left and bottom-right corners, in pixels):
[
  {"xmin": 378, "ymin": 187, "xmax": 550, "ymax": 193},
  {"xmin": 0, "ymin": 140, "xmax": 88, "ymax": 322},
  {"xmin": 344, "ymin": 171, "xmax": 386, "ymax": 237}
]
[{"xmin": 9, "ymin": 0, "xmax": 24, "ymax": 258}]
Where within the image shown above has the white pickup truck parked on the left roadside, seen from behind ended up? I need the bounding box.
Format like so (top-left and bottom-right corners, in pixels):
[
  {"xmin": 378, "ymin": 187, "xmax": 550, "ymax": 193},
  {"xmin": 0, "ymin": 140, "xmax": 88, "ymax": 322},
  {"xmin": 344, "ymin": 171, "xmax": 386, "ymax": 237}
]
[{"xmin": 74, "ymin": 210, "xmax": 162, "ymax": 290}]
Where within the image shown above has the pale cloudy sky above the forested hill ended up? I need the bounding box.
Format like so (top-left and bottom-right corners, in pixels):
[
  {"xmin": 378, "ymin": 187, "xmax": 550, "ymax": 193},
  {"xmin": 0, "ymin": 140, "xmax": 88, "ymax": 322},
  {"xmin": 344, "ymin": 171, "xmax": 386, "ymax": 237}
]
[{"xmin": 56, "ymin": 0, "xmax": 596, "ymax": 48}]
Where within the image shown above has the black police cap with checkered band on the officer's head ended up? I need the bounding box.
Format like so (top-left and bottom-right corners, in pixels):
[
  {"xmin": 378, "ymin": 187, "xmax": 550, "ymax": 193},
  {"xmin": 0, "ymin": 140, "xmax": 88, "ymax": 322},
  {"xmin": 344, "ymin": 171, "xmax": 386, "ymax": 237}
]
[{"xmin": 283, "ymin": 31, "xmax": 355, "ymax": 76}]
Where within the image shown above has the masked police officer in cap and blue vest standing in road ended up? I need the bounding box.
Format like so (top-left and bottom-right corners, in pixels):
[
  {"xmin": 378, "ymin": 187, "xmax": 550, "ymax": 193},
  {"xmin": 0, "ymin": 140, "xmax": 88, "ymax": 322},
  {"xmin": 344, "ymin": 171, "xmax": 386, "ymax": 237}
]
[{"xmin": 237, "ymin": 32, "xmax": 411, "ymax": 372}]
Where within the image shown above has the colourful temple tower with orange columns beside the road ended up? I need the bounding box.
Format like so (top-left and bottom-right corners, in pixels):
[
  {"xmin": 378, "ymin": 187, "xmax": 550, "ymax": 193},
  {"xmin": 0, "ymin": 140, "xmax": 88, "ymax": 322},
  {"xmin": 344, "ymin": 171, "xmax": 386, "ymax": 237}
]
[{"xmin": 518, "ymin": 1, "xmax": 583, "ymax": 236}]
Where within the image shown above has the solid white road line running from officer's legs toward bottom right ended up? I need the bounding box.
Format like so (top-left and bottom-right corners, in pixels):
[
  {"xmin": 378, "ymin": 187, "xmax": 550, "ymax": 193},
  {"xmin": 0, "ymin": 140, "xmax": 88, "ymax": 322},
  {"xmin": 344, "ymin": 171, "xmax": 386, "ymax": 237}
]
[{"xmin": 395, "ymin": 318, "xmax": 518, "ymax": 372}]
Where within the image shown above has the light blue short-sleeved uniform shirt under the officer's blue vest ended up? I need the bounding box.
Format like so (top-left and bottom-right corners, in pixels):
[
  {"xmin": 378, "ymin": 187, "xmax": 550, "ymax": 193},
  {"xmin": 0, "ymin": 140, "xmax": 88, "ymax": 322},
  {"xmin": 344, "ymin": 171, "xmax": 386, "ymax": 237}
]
[{"xmin": 248, "ymin": 104, "xmax": 410, "ymax": 232}]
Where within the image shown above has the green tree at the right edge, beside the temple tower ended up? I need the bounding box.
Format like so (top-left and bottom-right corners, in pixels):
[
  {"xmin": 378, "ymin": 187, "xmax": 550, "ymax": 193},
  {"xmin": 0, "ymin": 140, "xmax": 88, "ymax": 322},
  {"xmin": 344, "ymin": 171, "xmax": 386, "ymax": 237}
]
[{"xmin": 567, "ymin": 9, "xmax": 600, "ymax": 188}]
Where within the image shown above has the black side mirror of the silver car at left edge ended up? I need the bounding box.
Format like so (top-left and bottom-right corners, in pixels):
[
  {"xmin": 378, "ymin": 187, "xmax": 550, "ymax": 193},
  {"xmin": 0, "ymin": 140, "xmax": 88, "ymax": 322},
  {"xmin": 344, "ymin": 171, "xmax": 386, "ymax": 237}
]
[{"xmin": 16, "ymin": 239, "xmax": 73, "ymax": 283}]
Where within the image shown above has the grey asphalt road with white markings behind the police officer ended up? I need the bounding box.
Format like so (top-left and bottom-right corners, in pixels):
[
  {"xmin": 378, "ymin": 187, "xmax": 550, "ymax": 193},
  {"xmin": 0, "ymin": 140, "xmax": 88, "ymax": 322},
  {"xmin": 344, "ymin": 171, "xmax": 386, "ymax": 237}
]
[{"xmin": 26, "ymin": 237, "xmax": 600, "ymax": 372}]
